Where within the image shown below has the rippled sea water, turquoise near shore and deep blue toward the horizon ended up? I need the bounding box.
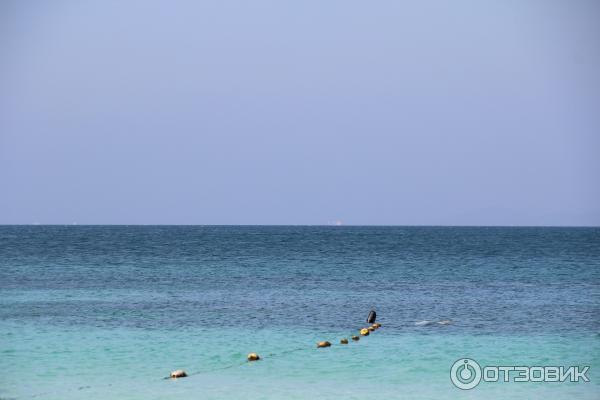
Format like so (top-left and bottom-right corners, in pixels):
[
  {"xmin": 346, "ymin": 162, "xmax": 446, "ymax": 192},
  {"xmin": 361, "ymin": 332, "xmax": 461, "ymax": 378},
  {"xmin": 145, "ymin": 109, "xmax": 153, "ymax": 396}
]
[{"xmin": 0, "ymin": 226, "xmax": 600, "ymax": 400}]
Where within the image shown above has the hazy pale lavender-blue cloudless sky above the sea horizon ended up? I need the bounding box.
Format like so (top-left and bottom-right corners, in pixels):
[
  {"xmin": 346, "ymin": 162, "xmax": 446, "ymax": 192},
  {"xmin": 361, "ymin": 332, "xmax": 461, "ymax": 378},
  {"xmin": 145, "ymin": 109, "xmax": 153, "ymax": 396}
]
[{"xmin": 0, "ymin": 0, "xmax": 600, "ymax": 225}]
